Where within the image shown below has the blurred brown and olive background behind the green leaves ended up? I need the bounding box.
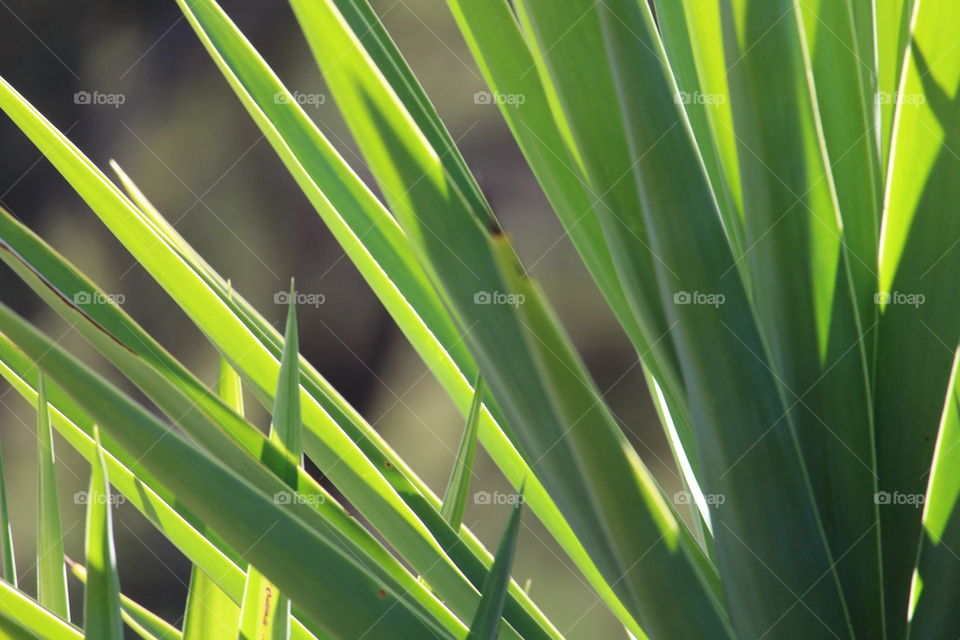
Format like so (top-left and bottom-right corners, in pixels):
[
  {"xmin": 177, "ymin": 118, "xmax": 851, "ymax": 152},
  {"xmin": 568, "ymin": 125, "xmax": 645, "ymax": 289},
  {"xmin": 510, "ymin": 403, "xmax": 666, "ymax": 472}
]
[{"xmin": 0, "ymin": 0, "xmax": 679, "ymax": 640}]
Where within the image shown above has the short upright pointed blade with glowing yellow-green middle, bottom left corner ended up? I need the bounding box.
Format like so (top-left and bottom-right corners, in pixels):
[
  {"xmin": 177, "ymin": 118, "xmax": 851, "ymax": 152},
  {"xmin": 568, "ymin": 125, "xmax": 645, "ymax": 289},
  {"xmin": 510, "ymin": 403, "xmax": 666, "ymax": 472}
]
[{"xmin": 83, "ymin": 427, "xmax": 123, "ymax": 640}]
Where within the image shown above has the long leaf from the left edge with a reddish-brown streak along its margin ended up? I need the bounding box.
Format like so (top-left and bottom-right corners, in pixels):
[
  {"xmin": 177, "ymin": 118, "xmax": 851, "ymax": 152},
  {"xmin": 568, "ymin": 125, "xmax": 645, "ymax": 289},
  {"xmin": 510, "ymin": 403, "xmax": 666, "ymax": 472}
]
[{"xmin": 0, "ymin": 209, "xmax": 479, "ymax": 636}]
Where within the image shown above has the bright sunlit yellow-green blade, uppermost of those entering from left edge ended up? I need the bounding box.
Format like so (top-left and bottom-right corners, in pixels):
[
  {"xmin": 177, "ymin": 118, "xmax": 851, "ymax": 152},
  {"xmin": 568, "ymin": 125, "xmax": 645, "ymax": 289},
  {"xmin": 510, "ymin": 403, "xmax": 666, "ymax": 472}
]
[{"xmin": 0, "ymin": 74, "xmax": 556, "ymax": 635}]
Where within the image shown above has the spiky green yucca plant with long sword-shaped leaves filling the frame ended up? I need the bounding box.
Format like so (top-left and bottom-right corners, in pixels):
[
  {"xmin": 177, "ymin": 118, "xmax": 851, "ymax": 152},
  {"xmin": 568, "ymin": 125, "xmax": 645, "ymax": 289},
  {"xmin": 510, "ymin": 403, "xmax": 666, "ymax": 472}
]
[{"xmin": 0, "ymin": 0, "xmax": 960, "ymax": 640}]
